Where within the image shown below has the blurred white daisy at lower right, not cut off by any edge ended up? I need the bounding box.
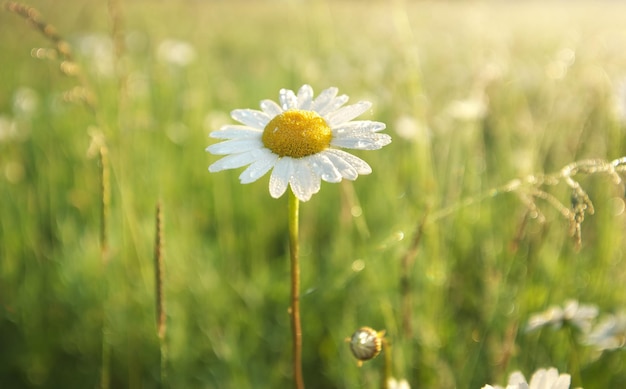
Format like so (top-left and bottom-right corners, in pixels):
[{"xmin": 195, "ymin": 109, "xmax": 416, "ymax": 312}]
[{"xmin": 526, "ymin": 300, "xmax": 598, "ymax": 332}]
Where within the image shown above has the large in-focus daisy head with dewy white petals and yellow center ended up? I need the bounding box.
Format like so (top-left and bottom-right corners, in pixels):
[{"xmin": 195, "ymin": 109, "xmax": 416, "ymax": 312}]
[{"xmin": 206, "ymin": 85, "xmax": 391, "ymax": 201}]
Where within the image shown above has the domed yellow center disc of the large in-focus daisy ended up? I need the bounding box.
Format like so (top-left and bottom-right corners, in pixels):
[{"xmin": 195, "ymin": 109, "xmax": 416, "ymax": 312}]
[{"xmin": 261, "ymin": 109, "xmax": 332, "ymax": 158}]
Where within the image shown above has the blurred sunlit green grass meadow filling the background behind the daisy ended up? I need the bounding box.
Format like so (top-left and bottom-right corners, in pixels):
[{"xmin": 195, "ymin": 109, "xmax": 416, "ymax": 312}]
[{"xmin": 0, "ymin": 0, "xmax": 626, "ymax": 389}]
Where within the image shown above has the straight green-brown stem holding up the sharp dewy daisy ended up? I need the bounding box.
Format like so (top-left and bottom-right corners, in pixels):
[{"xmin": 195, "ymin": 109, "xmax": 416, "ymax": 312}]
[{"xmin": 288, "ymin": 188, "xmax": 304, "ymax": 389}]
